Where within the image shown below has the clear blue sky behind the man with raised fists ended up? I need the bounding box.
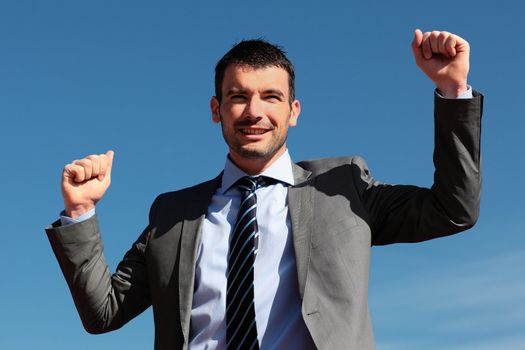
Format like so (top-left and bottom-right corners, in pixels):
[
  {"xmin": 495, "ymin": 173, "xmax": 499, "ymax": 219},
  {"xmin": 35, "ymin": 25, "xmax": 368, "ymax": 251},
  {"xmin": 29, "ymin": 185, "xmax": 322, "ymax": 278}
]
[{"xmin": 0, "ymin": 0, "xmax": 525, "ymax": 350}]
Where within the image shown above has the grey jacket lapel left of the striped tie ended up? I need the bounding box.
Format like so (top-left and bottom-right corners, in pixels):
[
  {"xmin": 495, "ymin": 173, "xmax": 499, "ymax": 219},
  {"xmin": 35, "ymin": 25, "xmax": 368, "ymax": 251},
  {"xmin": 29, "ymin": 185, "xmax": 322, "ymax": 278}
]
[{"xmin": 179, "ymin": 173, "xmax": 222, "ymax": 344}]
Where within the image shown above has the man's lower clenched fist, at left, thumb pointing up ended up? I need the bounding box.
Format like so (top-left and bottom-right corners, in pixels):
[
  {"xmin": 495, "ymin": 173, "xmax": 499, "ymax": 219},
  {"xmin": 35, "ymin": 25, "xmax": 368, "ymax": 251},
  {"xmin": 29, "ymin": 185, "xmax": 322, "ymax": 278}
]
[{"xmin": 62, "ymin": 151, "xmax": 114, "ymax": 218}]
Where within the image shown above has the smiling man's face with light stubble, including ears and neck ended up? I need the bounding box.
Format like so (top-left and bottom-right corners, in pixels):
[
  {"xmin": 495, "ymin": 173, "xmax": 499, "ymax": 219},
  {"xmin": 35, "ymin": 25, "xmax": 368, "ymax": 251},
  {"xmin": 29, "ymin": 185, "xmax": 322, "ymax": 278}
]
[{"xmin": 210, "ymin": 65, "xmax": 300, "ymax": 173}]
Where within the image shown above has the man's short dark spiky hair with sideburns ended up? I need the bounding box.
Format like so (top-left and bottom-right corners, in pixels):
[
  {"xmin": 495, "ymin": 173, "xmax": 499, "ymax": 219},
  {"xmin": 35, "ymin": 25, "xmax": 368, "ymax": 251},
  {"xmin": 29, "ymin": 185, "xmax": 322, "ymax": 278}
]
[{"xmin": 215, "ymin": 39, "xmax": 295, "ymax": 103}]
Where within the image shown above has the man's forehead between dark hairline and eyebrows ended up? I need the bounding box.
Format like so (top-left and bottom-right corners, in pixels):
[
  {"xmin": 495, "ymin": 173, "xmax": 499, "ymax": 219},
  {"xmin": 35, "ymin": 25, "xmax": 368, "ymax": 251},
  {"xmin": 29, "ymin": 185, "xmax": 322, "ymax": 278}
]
[{"xmin": 222, "ymin": 65, "xmax": 289, "ymax": 95}]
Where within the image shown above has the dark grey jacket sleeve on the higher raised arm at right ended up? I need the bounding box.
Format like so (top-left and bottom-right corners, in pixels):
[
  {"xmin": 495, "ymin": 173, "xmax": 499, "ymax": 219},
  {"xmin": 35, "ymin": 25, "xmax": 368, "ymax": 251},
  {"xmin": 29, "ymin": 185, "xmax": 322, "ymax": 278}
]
[{"xmin": 355, "ymin": 91, "xmax": 483, "ymax": 245}]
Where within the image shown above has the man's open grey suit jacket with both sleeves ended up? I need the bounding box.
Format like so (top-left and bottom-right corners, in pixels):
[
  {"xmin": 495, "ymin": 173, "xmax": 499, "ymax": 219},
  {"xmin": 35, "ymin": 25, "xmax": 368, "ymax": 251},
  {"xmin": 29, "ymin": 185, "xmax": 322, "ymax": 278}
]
[{"xmin": 46, "ymin": 93, "xmax": 482, "ymax": 350}]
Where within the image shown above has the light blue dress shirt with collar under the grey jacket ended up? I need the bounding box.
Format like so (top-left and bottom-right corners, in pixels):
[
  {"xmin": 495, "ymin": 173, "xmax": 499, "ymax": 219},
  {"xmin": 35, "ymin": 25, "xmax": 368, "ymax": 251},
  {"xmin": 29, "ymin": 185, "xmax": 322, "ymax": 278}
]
[{"xmin": 190, "ymin": 152, "xmax": 315, "ymax": 350}]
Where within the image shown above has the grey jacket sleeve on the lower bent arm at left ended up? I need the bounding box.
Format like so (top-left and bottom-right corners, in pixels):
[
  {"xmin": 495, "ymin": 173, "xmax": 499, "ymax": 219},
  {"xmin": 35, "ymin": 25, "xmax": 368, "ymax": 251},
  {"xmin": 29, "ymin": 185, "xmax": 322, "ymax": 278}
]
[{"xmin": 46, "ymin": 200, "xmax": 157, "ymax": 334}]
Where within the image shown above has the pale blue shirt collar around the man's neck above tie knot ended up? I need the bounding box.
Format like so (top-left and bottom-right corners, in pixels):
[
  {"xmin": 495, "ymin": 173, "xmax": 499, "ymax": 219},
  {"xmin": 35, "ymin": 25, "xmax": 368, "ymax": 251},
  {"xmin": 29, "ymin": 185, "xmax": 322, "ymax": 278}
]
[{"xmin": 217, "ymin": 150, "xmax": 294, "ymax": 193}]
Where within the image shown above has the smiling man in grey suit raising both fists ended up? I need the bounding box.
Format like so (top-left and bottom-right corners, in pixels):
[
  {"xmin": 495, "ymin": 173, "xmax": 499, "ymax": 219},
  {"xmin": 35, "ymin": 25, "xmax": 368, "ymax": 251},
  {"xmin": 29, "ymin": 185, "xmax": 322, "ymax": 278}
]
[{"xmin": 47, "ymin": 30, "xmax": 482, "ymax": 349}]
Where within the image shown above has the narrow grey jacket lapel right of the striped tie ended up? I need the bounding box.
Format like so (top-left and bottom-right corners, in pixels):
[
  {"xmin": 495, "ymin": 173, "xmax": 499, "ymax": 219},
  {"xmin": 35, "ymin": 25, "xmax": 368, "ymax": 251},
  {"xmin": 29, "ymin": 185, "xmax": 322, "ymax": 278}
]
[{"xmin": 288, "ymin": 164, "xmax": 313, "ymax": 298}]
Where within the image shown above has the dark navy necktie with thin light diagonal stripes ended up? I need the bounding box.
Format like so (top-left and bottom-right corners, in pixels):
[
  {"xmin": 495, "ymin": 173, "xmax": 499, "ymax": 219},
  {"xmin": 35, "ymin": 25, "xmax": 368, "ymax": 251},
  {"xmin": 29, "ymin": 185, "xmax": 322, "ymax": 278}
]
[{"xmin": 226, "ymin": 176, "xmax": 263, "ymax": 350}]
